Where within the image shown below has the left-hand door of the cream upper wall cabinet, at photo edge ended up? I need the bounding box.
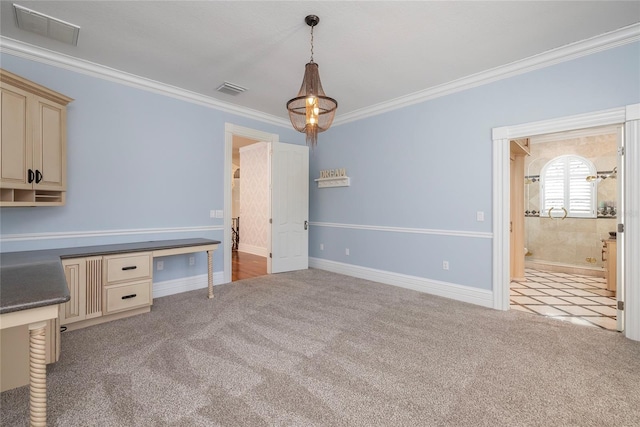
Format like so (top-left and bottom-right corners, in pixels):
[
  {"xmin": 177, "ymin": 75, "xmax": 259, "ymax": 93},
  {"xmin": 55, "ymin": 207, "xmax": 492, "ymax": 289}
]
[{"xmin": 0, "ymin": 86, "xmax": 35, "ymax": 189}]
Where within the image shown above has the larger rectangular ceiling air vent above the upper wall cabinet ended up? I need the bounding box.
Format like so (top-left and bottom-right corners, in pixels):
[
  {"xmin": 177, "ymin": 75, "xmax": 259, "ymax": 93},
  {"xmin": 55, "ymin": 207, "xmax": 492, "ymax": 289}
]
[{"xmin": 13, "ymin": 3, "xmax": 80, "ymax": 46}]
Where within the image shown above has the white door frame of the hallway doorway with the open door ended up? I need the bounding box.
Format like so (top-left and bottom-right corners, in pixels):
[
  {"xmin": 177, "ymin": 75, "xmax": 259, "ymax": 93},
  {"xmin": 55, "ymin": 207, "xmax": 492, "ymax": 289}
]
[{"xmin": 222, "ymin": 123, "xmax": 280, "ymax": 283}]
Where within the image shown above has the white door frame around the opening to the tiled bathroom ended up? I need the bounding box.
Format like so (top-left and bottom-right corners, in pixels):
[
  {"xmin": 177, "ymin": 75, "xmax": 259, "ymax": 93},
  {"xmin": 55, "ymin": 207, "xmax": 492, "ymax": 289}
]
[{"xmin": 492, "ymin": 104, "xmax": 640, "ymax": 341}]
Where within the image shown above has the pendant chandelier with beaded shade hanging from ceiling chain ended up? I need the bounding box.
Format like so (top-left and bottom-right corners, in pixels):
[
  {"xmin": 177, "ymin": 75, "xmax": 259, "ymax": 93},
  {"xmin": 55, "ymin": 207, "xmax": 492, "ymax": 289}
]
[{"xmin": 287, "ymin": 15, "xmax": 338, "ymax": 148}]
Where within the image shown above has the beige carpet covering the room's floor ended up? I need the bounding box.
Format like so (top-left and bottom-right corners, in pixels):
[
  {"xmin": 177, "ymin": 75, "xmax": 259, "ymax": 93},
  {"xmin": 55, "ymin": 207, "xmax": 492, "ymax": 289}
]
[{"xmin": 0, "ymin": 270, "xmax": 640, "ymax": 426}]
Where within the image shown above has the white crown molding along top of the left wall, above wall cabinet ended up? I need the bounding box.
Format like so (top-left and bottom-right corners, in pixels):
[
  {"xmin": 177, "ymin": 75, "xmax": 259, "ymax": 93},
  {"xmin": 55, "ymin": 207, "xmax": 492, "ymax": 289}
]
[{"xmin": 0, "ymin": 36, "xmax": 291, "ymax": 127}]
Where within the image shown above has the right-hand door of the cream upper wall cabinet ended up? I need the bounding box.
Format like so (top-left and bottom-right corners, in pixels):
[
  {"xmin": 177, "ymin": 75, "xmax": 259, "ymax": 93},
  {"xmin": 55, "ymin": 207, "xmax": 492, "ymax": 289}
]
[{"xmin": 33, "ymin": 97, "xmax": 67, "ymax": 191}]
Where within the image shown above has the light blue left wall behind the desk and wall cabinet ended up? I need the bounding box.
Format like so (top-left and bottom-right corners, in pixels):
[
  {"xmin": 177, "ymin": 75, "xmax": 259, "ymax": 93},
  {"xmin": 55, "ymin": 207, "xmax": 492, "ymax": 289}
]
[{"xmin": 0, "ymin": 54, "xmax": 304, "ymax": 281}]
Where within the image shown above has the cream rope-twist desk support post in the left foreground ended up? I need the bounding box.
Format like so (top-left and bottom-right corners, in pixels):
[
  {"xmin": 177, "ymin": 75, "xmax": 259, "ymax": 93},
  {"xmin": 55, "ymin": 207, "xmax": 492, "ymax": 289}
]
[{"xmin": 29, "ymin": 322, "xmax": 47, "ymax": 426}]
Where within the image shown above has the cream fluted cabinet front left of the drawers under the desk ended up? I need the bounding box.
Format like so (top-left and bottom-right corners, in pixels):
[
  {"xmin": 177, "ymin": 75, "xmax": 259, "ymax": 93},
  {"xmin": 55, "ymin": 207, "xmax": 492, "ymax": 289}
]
[{"xmin": 60, "ymin": 257, "xmax": 102, "ymax": 325}]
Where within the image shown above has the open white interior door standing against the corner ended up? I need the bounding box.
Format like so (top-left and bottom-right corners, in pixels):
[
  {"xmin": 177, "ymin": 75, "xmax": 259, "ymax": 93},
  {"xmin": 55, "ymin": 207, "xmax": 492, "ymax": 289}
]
[{"xmin": 267, "ymin": 142, "xmax": 309, "ymax": 274}]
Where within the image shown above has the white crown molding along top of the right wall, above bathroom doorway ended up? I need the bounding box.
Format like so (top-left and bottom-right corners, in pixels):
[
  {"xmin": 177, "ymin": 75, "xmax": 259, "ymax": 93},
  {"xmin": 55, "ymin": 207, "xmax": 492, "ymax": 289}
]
[{"xmin": 333, "ymin": 23, "xmax": 640, "ymax": 126}]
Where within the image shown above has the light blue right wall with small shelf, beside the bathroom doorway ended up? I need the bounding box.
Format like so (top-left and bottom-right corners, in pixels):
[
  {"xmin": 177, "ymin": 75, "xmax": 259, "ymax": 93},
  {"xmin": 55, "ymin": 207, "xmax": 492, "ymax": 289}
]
[{"xmin": 309, "ymin": 43, "xmax": 640, "ymax": 289}]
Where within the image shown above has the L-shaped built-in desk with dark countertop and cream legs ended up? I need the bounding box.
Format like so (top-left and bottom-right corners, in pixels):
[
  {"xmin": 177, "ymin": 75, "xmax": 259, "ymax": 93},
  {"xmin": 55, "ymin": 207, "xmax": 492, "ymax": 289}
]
[{"xmin": 0, "ymin": 239, "xmax": 220, "ymax": 426}]
